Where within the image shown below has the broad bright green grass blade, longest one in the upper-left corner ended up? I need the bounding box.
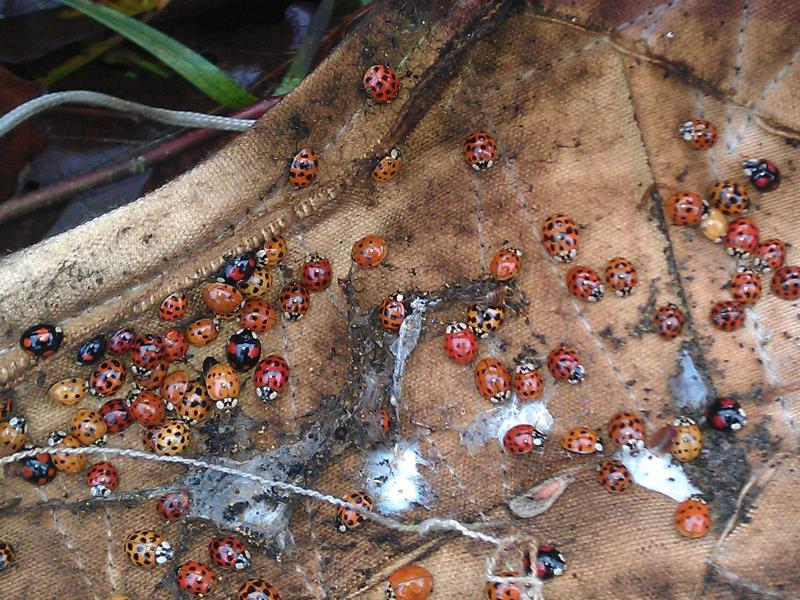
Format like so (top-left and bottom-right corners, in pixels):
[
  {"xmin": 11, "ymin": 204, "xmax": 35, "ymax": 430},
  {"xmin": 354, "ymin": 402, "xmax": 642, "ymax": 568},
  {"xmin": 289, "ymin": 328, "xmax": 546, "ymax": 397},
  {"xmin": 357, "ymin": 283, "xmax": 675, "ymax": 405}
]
[{"xmin": 61, "ymin": 0, "xmax": 257, "ymax": 108}]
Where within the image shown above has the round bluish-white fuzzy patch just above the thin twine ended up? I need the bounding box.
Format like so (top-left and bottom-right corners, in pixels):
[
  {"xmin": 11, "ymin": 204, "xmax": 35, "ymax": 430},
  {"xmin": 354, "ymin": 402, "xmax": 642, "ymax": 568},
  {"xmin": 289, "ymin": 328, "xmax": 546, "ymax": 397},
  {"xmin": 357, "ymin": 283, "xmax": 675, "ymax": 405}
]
[{"xmin": 365, "ymin": 441, "xmax": 433, "ymax": 513}]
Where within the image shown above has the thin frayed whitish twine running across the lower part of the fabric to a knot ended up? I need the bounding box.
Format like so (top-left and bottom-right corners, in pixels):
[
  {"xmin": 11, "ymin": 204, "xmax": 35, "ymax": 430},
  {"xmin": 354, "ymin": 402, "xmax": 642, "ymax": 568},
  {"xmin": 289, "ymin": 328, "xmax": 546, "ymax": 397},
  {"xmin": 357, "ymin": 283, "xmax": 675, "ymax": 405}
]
[{"xmin": 0, "ymin": 446, "xmax": 543, "ymax": 600}]
